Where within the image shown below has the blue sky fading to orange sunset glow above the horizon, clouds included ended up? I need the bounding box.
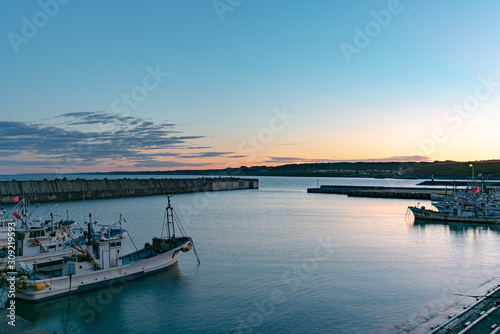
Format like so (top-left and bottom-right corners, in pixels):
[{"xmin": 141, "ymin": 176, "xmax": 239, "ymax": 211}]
[{"xmin": 0, "ymin": 0, "xmax": 500, "ymax": 174}]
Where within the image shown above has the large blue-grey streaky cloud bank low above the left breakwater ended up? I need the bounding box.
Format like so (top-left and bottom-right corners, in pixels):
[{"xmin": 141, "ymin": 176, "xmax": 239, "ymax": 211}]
[{"xmin": 0, "ymin": 111, "xmax": 208, "ymax": 172}]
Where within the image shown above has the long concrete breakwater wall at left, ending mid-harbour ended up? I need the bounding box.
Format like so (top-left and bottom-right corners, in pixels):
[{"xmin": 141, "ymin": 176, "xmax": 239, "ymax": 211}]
[{"xmin": 0, "ymin": 177, "xmax": 259, "ymax": 204}]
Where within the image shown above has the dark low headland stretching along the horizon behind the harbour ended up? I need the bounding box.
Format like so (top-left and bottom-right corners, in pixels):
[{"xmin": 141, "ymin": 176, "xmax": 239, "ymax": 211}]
[{"xmin": 60, "ymin": 160, "xmax": 500, "ymax": 179}]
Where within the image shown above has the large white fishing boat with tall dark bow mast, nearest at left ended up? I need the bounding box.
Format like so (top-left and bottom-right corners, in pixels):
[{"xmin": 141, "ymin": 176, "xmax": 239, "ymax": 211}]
[{"xmin": 3, "ymin": 196, "xmax": 199, "ymax": 302}]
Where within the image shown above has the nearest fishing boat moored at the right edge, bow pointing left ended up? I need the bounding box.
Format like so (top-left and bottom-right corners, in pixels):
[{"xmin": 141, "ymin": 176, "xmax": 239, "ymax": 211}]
[{"xmin": 408, "ymin": 205, "xmax": 500, "ymax": 224}]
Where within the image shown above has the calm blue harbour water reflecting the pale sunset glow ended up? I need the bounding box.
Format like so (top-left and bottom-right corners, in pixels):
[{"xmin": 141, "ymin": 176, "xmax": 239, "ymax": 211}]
[{"xmin": 3, "ymin": 176, "xmax": 500, "ymax": 333}]
